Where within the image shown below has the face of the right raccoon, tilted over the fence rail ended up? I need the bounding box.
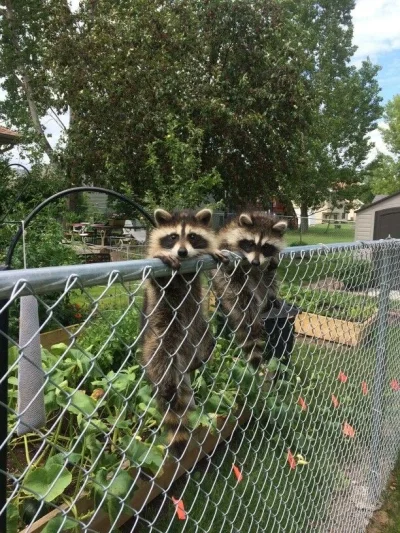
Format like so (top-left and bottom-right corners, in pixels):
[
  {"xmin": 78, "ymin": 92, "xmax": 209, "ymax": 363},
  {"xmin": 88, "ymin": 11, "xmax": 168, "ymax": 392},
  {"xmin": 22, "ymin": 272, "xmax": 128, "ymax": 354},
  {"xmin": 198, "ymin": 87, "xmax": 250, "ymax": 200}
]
[{"xmin": 221, "ymin": 213, "xmax": 286, "ymax": 266}]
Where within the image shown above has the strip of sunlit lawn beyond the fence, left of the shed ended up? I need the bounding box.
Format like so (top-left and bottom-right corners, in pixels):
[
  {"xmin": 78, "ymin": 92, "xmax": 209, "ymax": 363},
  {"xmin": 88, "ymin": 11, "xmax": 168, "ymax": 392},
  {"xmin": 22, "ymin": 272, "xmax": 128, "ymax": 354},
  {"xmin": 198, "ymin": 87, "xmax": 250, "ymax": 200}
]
[{"xmin": 286, "ymin": 224, "xmax": 355, "ymax": 246}]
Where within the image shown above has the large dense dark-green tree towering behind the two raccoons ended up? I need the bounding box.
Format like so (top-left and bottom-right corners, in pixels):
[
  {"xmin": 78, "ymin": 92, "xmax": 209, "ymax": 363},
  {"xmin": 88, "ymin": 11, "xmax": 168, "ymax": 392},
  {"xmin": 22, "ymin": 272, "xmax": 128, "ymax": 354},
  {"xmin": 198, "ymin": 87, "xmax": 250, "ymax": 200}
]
[{"xmin": 0, "ymin": 0, "xmax": 310, "ymax": 205}]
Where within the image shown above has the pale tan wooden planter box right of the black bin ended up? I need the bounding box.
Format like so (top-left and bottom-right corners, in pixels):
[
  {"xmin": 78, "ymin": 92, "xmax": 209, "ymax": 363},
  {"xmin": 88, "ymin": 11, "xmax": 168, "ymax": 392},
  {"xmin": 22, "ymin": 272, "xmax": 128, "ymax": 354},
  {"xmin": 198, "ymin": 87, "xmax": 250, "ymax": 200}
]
[{"xmin": 295, "ymin": 311, "xmax": 376, "ymax": 346}]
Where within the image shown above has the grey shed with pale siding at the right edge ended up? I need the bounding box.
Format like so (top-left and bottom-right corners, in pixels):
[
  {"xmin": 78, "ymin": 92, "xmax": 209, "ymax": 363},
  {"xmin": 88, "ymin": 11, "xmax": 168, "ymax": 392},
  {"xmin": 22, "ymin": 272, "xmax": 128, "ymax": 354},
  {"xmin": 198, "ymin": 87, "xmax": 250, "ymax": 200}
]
[{"xmin": 355, "ymin": 191, "xmax": 400, "ymax": 241}]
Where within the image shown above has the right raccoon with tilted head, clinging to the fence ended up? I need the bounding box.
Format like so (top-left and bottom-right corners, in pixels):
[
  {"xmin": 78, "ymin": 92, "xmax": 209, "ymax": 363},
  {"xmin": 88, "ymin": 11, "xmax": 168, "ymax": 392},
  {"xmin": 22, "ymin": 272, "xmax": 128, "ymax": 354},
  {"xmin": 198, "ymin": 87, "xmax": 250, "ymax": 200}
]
[{"xmin": 213, "ymin": 212, "xmax": 287, "ymax": 368}]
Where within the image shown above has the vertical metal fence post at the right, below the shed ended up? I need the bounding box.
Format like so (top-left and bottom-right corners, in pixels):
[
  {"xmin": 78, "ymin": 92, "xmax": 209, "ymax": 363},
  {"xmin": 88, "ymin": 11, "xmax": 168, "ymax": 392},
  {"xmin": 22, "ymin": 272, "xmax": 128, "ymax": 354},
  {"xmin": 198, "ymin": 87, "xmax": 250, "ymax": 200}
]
[{"xmin": 370, "ymin": 241, "xmax": 391, "ymax": 505}]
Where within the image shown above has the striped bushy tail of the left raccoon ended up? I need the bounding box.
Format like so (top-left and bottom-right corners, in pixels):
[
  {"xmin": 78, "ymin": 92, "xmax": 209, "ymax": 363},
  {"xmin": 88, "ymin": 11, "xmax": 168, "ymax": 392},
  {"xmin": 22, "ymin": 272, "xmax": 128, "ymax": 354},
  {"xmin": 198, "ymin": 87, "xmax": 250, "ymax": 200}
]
[{"xmin": 160, "ymin": 374, "xmax": 195, "ymax": 459}]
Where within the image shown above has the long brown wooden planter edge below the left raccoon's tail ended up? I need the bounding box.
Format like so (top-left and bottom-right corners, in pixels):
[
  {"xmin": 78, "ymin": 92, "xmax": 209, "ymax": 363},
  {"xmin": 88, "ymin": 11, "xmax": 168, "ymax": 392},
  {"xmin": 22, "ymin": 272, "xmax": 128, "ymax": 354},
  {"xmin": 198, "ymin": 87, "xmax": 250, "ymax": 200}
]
[{"xmin": 20, "ymin": 410, "xmax": 251, "ymax": 533}]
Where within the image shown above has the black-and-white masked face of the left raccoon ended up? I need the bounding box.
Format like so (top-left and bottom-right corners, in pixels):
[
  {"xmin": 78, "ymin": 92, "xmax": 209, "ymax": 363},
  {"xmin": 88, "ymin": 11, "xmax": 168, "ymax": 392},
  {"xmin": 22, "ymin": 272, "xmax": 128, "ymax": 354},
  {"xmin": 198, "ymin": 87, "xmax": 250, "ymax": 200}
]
[{"xmin": 151, "ymin": 209, "xmax": 215, "ymax": 259}]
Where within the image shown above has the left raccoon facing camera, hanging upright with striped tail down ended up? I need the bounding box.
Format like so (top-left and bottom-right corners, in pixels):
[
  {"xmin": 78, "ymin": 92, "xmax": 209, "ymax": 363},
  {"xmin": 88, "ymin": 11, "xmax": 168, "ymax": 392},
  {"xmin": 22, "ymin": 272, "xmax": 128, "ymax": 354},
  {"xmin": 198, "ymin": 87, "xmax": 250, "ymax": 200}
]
[{"xmin": 143, "ymin": 209, "xmax": 229, "ymax": 455}]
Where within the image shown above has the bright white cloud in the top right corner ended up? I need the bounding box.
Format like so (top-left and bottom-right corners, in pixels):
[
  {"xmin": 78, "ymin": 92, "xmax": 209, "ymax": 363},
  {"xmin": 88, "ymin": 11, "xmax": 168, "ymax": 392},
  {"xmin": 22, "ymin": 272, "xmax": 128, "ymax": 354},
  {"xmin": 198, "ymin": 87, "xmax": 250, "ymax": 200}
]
[{"xmin": 353, "ymin": 0, "xmax": 400, "ymax": 61}]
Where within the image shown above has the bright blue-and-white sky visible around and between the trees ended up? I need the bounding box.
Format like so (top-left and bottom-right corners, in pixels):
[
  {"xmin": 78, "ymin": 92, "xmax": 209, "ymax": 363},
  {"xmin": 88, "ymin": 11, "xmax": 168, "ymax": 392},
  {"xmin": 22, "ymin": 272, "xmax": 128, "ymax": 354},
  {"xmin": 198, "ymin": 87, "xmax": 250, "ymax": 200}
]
[{"xmin": 5, "ymin": 0, "xmax": 400, "ymax": 164}]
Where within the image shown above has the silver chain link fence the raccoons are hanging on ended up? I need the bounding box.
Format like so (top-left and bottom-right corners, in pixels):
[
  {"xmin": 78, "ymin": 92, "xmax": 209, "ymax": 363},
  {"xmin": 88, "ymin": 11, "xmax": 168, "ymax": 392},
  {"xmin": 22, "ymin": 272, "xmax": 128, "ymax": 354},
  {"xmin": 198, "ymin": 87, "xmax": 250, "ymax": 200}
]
[{"xmin": 0, "ymin": 240, "xmax": 400, "ymax": 533}]
